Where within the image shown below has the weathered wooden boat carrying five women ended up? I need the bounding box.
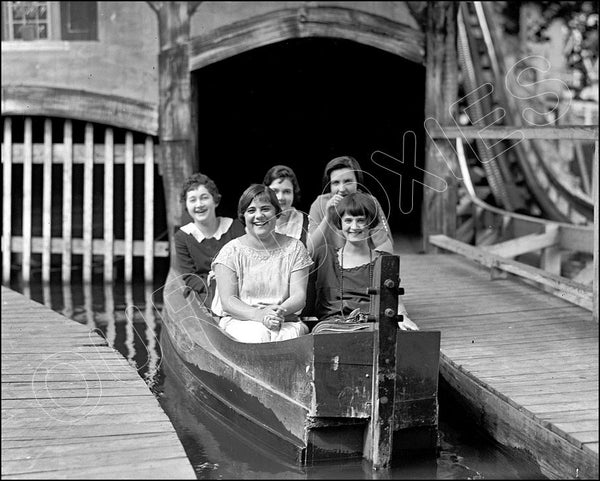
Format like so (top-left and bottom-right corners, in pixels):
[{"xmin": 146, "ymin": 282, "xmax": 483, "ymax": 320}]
[{"xmin": 161, "ymin": 256, "xmax": 440, "ymax": 467}]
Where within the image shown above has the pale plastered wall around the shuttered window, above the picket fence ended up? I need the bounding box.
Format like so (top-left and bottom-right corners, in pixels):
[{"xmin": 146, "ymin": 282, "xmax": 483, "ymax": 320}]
[{"xmin": 2, "ymin": 2, "xmax": 158, "ymax": 105}]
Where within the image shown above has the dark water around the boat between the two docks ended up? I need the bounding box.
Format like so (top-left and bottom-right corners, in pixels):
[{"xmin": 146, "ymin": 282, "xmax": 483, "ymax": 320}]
[{"xmin": 11, "ymin": 279, "xmax": 544, "ymax": 479}]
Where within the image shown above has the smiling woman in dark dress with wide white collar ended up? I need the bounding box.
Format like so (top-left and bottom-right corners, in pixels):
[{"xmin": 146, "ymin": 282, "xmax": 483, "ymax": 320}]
[{"xmin": 175, "ymin": 173, "xmax": 244, "ymax": 300}]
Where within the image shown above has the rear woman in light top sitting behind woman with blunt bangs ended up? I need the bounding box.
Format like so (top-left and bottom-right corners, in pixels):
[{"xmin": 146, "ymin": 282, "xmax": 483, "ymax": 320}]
[{"xmin": 308, "ymin": 155, "xmax": 394, "ymax": 252}]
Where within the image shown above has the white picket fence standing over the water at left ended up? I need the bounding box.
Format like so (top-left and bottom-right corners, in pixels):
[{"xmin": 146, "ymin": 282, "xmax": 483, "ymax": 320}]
[{"xmin": 2, "ymin": 117, "xmax": 169, "ymax": 283}]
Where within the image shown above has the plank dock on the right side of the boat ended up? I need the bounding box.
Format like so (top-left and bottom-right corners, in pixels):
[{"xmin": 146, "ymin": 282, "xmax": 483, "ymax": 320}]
[{"xmin": 400, "ymin": 254, "xmax": 598, "ymax": 479}]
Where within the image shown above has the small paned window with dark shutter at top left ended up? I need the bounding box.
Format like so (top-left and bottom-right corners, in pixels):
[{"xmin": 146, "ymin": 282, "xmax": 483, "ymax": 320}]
[{"xmin": 2, "ymin": 2, "xmax": 98, "ymax": 41}]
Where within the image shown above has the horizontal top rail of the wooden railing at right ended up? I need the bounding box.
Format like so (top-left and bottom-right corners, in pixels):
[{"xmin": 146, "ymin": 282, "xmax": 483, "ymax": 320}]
[{"xmin": 427, "ymin": 122, "xmax": 598, "ymax": 141}]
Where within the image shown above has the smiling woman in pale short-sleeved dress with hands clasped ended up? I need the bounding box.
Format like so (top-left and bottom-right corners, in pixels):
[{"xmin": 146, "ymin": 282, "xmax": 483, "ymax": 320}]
[{"xmin": 212, "ymin": 184, "xmax": 312, "ymax": 342}]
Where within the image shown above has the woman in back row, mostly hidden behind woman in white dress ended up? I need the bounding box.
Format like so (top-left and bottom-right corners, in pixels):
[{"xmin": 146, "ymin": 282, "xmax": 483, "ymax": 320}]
[{"xmin": 263, "ymin": 165, "xmax": 308, "ymax": 245}]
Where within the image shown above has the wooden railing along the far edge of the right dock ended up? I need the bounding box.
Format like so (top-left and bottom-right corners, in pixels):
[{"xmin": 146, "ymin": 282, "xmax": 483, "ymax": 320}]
[{"xmin": 429, "ymin": 126, "xmax": 599, "ymax": 322}]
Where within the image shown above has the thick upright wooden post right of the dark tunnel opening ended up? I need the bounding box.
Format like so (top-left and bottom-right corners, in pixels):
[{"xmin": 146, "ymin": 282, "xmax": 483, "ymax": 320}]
[{"xmin": 421, "ymin": 2, "xmax": 459, "ymax": 251}]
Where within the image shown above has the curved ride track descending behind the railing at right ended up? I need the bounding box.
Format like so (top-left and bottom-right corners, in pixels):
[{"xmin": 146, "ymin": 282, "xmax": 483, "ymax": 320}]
[{"xmin": 458, "ymin": 2, "xmax": 594, "ymax": 224}]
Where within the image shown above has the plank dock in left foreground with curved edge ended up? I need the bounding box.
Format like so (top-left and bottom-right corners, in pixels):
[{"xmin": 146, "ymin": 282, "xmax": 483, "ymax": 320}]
[{"xmin": 2, "ymin": 286, "xmax": 196, "ymax": 479}]
